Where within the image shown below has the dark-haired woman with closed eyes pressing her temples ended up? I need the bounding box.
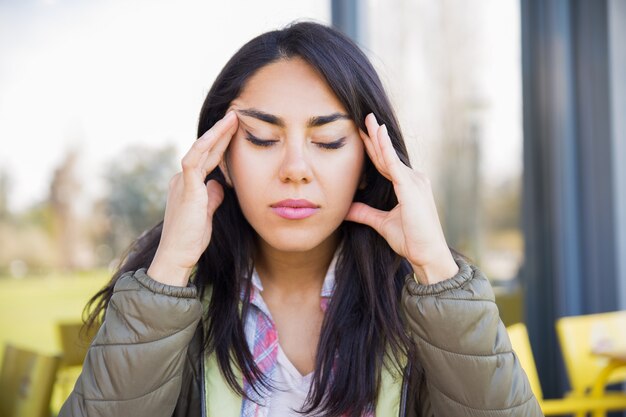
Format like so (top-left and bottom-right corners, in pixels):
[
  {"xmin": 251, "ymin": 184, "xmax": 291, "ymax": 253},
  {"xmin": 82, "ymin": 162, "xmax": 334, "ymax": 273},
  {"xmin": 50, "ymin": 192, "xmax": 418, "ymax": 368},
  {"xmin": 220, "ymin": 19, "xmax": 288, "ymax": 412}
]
[{"xmin": 61, "ymin": 22, "xmax": 541, "ymax": 417}]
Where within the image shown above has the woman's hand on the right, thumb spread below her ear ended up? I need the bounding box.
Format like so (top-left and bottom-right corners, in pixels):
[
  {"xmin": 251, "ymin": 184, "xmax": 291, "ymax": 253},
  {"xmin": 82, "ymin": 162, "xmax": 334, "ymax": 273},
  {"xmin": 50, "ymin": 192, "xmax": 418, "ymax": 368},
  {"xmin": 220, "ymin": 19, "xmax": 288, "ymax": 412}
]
[{"xmin": 346, "ymin": 113, "xmax": 459, "ymax": 285}]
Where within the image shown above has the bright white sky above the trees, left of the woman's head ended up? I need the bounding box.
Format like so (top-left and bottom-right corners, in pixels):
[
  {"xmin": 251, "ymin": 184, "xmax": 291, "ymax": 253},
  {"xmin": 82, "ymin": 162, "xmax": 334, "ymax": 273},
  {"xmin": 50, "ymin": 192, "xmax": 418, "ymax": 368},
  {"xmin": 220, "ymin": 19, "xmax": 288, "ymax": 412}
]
[{"xmin": 0, "ymin": 0, "xmax": 330, "ymax": 210}]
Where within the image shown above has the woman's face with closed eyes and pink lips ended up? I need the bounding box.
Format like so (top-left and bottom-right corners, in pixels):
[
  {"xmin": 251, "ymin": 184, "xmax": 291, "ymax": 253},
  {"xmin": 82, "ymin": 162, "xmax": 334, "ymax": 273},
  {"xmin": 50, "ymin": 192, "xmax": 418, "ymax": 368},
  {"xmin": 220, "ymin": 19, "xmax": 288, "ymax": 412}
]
[{"xmin": 221, "ymin": 58, "xmax": 364, "ymax": 252}]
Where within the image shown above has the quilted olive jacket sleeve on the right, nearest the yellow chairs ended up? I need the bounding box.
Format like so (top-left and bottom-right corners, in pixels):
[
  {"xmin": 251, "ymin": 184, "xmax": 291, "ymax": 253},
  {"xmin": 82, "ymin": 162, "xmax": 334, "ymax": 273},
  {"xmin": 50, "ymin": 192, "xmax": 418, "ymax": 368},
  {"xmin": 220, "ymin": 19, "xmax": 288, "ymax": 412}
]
[{"xmin": 402, "ymin": 257, "xmax": 543, "ymax": 417}]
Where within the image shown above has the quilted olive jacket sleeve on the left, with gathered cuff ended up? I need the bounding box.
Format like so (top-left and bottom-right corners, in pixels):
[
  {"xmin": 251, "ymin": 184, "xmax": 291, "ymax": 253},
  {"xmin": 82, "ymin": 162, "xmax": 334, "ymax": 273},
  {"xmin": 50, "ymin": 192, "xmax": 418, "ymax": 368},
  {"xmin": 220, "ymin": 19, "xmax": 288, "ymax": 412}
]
[{"xmin": 59, "ymin": 268, "xmax": 202, "ymax": 417}]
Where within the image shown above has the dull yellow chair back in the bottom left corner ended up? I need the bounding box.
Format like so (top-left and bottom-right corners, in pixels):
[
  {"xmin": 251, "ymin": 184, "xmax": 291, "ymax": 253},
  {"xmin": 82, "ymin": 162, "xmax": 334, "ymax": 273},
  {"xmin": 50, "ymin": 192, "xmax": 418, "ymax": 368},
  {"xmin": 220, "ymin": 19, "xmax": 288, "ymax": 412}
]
[{"xmin": 0, "ymin": 345, "xmax": 60, "ymax": 417}]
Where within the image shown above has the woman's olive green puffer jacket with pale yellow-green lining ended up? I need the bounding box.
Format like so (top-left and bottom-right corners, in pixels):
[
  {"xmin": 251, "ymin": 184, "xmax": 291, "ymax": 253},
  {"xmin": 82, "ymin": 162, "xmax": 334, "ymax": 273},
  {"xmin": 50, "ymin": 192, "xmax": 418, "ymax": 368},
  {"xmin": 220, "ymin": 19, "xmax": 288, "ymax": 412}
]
[{"xmin": 60, "ymin": 258, "xmax": 543, "ymax": 417}]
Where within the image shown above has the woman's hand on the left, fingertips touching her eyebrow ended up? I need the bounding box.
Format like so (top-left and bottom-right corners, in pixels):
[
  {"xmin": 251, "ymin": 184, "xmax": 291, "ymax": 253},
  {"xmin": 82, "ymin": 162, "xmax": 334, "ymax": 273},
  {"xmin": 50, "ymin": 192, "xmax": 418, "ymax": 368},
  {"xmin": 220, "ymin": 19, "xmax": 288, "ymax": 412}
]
[{"xmin": 147, "ymin": 111, "xmax": 238, "ymax": 287}]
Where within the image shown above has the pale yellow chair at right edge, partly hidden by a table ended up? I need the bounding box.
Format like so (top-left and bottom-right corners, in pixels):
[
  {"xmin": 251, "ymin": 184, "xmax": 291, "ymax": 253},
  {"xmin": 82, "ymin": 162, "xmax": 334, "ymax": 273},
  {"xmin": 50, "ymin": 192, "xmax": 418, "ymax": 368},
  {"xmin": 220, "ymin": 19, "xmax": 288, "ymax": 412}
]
[{"xmin": 556, "ymin": 311, "xmax": 626, "ymax": 417}]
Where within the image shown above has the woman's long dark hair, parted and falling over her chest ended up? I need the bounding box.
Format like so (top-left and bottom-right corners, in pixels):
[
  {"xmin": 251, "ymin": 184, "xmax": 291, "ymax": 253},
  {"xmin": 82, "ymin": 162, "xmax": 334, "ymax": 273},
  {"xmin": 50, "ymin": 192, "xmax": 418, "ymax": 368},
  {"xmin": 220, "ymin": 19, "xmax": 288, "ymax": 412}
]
[{"xmin": 86, "ymin": 21, "xmax": 422, "ymax": 417}]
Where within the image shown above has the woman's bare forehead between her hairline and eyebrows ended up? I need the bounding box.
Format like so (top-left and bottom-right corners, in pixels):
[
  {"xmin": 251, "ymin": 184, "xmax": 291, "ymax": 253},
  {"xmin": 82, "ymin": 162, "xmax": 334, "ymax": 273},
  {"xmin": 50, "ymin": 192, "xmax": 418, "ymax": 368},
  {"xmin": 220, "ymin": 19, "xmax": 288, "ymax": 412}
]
[{"xmin": 231, "ymin": 58, "xmax": 347, "ymax": 123}]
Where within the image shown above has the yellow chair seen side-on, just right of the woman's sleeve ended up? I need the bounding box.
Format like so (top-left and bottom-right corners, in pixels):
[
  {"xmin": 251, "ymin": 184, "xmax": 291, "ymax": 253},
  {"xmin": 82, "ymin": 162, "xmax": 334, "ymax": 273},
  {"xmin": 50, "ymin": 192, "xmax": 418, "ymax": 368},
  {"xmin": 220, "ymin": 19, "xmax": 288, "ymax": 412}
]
[{"xmin": 507, "ymin": 323, "xmax": 624, "ymax": 417}]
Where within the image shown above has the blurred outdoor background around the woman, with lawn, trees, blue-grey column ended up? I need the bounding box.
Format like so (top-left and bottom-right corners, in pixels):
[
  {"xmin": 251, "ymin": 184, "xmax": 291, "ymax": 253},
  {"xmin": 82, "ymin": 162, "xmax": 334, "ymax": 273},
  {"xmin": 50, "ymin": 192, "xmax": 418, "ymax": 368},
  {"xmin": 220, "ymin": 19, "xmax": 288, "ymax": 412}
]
[{"xmin": 0, "ymin": 0, "xmax": 626, "ymax": 412}]
